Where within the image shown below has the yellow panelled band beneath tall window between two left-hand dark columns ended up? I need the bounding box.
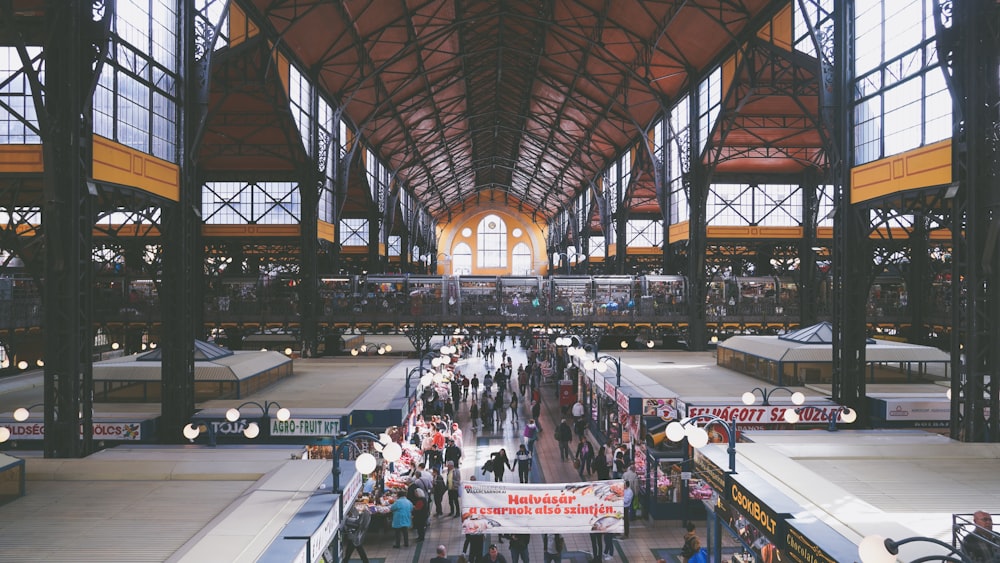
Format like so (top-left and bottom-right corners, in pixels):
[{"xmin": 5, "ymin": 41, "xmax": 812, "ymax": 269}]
[{"xmin": 93, "ymin": 135, "xmax": 181, "ymax": 201}]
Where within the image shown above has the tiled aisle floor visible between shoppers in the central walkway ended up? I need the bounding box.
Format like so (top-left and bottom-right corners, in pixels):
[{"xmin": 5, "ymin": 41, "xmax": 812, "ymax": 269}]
[{"xmin": 351, "ymin": 340, "xmax": 704, "ymax": 563}]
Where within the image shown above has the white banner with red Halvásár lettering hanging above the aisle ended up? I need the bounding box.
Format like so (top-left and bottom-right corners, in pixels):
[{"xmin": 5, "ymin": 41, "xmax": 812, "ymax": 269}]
[{"xmin": 462, "ymin": 480, "xmax": 625, "ymax": 534}]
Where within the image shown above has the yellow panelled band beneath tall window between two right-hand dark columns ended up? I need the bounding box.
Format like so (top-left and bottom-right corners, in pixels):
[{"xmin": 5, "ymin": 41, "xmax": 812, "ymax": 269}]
[{"xmin": 851, "ymin": 139, "xmax": 952, "ymax": 203}]
